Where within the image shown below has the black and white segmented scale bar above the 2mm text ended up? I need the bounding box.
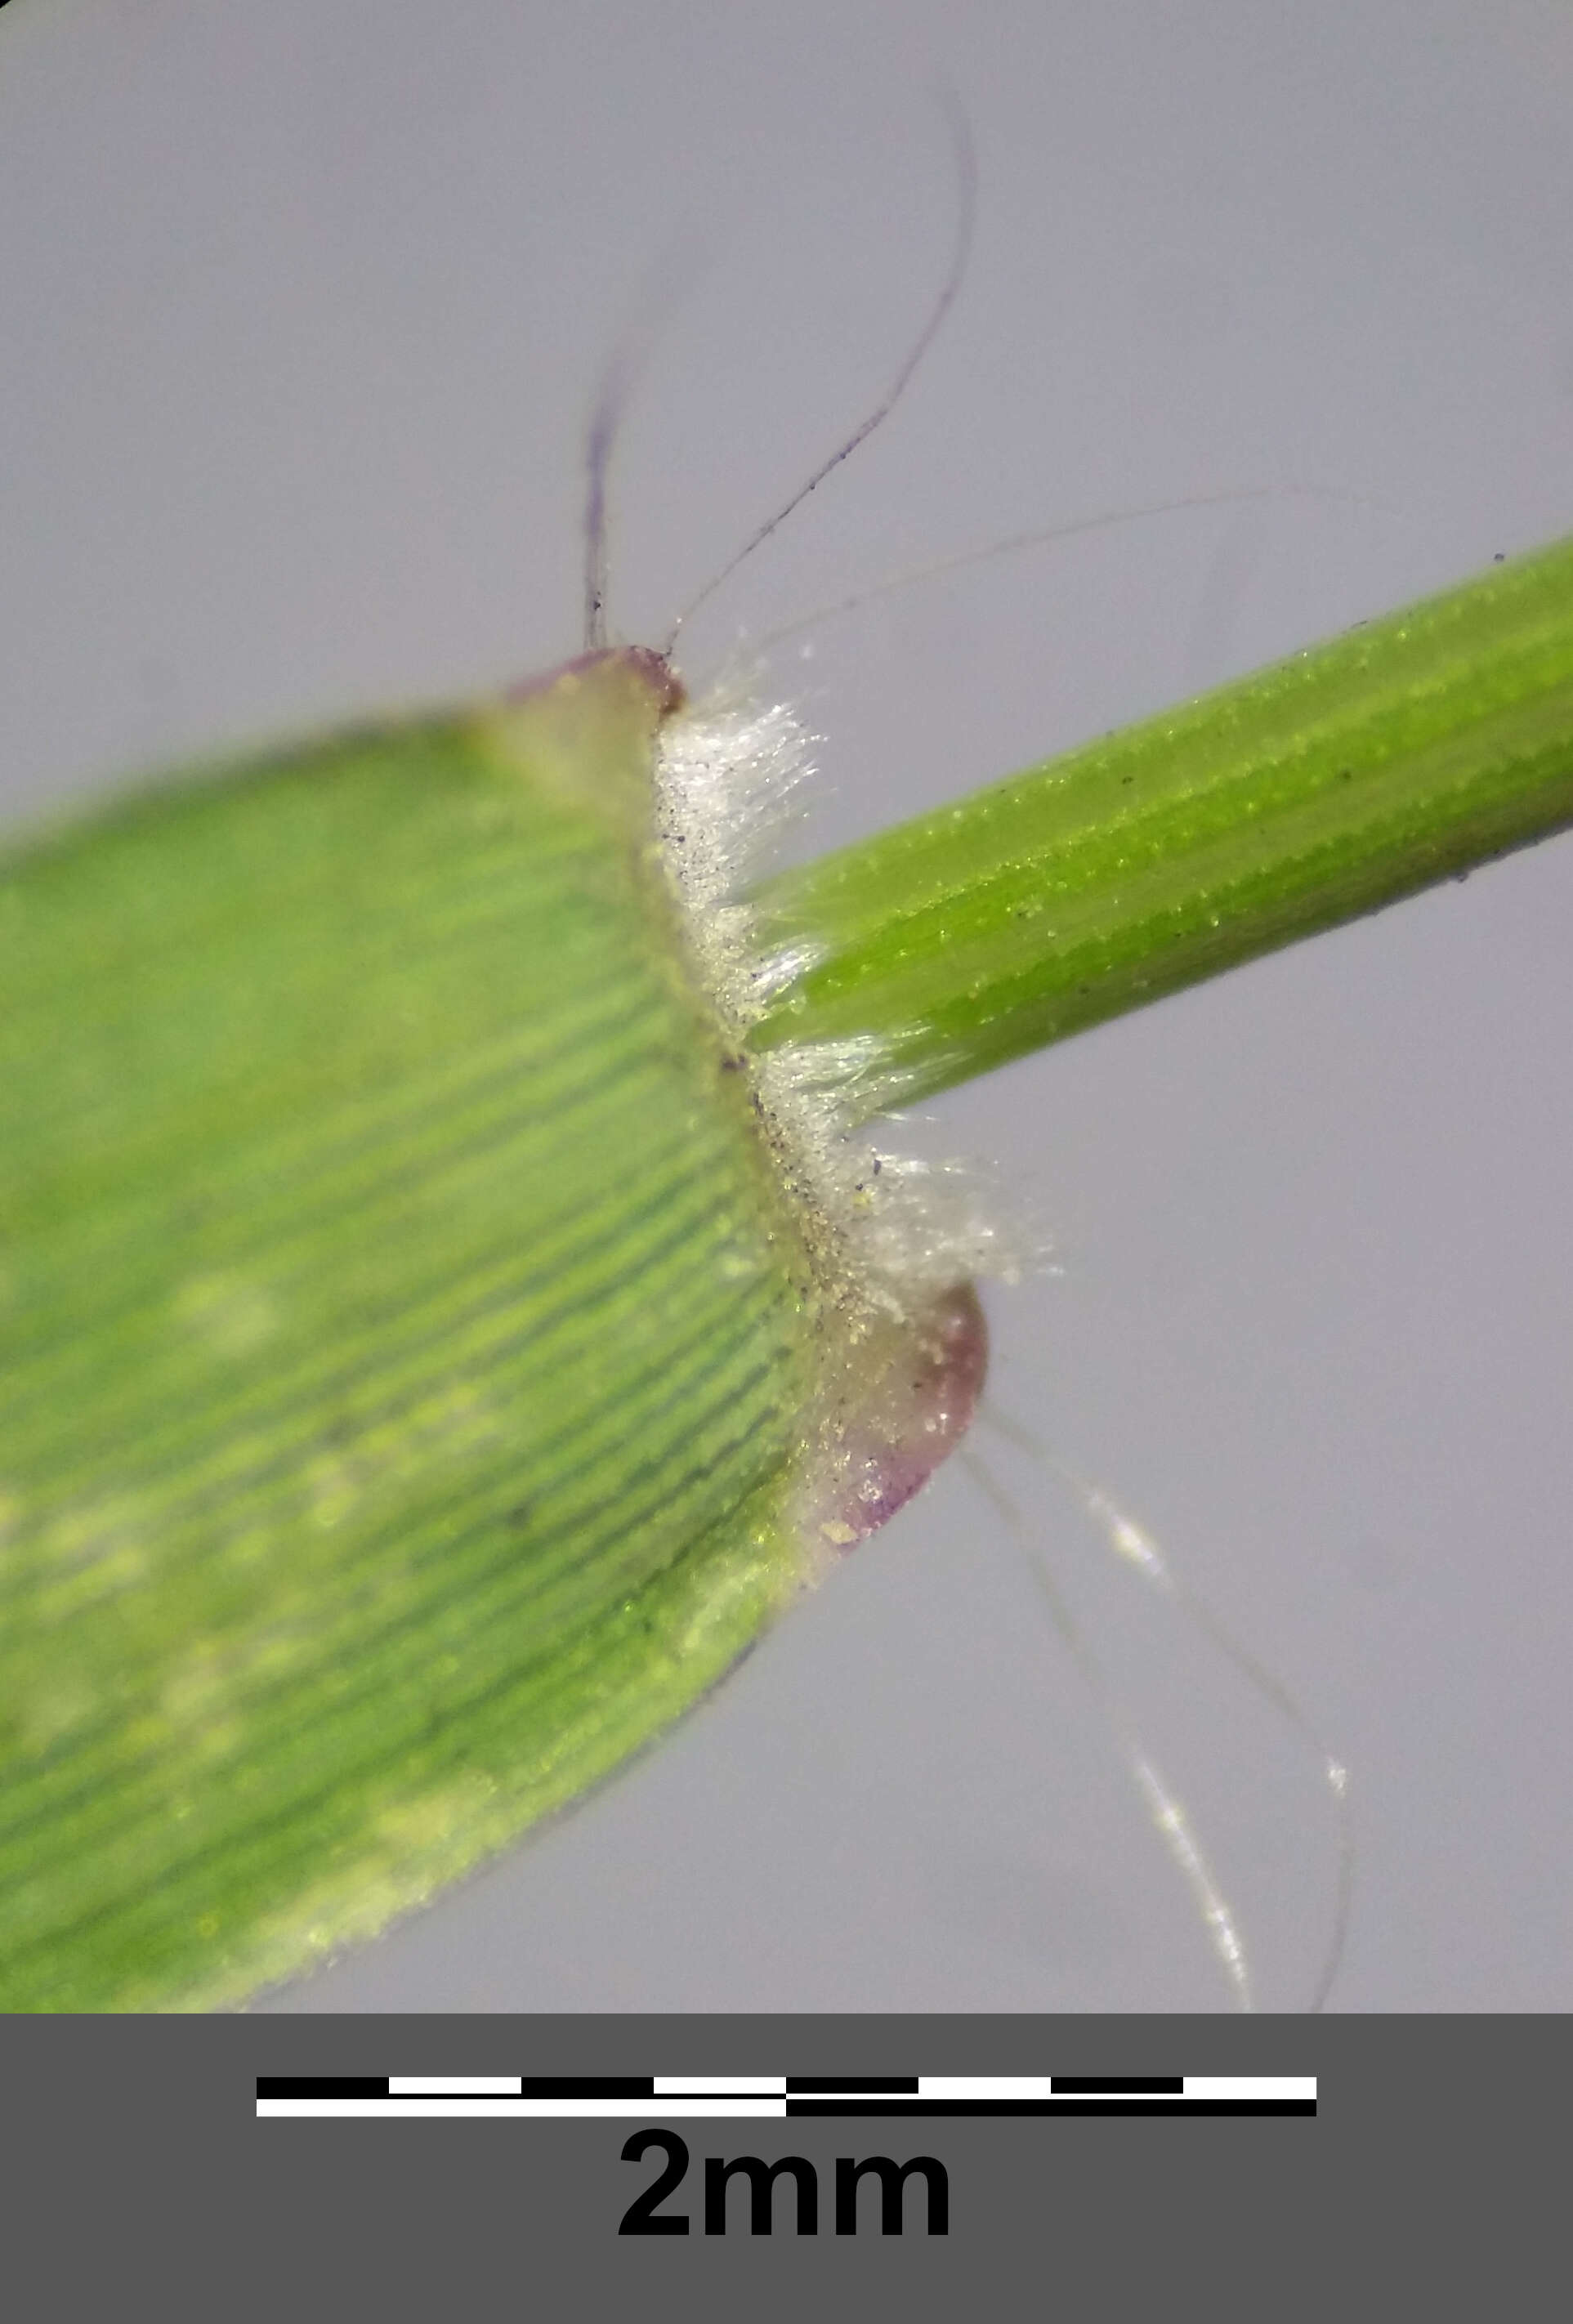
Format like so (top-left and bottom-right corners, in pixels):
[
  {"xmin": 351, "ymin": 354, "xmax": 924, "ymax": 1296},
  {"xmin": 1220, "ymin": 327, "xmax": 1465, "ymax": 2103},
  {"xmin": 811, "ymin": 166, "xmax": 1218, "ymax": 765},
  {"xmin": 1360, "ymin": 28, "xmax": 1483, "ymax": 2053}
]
[{"xmin": 256, "ymin": 2073, "xmax": 1317, "ymax": 2122}]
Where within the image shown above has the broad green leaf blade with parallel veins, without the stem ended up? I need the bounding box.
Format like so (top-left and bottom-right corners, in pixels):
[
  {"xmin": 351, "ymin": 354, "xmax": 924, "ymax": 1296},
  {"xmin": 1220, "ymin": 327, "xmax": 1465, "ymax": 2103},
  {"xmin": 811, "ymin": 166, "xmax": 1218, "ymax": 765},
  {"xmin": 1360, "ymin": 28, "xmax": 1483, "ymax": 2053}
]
[{"xmin": 0, "ymin": 655, "xmax": 980, "ymax": 2008}]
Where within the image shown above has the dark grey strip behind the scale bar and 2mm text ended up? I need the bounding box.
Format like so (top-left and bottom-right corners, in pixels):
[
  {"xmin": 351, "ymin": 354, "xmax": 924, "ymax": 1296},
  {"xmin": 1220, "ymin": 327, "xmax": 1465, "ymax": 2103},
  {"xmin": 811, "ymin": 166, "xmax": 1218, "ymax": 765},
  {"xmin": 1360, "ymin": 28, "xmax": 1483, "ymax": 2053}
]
[{"xmin": 9, "ymin": 2018, "xmax": 1486, "ymax": 2324}]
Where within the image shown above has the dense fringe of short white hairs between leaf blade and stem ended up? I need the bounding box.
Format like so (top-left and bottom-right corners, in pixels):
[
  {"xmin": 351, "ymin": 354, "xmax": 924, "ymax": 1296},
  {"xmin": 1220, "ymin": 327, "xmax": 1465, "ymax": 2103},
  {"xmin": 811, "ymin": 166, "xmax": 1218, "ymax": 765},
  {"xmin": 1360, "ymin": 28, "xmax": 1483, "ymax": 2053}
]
[{"xmin": 655, "ymin": 678, "xmax": 1041, "ymax": 1313}]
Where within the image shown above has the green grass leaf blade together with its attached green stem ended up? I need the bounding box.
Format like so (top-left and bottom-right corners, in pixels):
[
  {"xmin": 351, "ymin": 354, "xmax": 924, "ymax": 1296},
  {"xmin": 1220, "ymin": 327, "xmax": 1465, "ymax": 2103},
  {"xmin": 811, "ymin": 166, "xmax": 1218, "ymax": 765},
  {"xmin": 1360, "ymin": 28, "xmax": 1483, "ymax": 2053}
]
[{"xmin": 0, "ymin": 543, "xmax": 1573, "ymax": 2008}]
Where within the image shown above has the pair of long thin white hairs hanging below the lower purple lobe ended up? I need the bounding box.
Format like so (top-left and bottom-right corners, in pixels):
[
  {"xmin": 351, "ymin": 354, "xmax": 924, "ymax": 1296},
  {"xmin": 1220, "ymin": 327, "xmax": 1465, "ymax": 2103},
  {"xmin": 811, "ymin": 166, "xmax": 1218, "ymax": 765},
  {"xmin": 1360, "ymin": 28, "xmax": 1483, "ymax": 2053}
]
[{"xmin": 959, "ymin": 1401, "xmax": 1355, "ymax": 2015}]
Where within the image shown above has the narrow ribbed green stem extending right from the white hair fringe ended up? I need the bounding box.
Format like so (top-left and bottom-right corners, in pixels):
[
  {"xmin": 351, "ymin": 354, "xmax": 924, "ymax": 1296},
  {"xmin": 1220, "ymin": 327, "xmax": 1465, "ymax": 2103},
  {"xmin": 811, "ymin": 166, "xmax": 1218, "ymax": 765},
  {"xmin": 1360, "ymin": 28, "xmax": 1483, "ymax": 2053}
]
[{"xmin": 755, "ymin": 525, "xmax": 1573, "ymax": 1111}]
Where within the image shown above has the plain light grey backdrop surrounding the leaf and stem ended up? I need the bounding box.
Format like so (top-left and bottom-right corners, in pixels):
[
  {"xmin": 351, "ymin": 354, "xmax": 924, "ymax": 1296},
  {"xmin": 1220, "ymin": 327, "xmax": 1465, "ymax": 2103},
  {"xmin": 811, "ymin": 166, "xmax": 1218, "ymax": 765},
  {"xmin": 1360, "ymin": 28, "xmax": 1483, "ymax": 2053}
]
[{"xmin": 0, "ymin": 0, "xmax": 1573, "ymax": 2010}]
